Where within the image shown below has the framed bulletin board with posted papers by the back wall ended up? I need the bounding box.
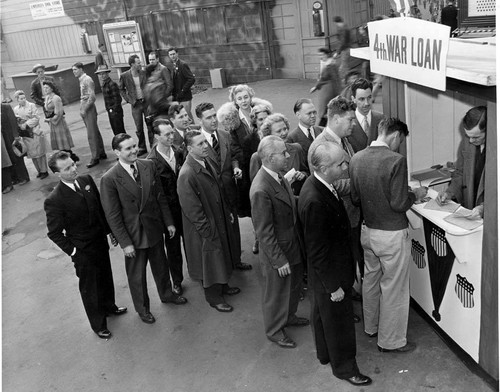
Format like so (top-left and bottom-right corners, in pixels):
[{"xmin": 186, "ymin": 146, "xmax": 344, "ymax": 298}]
[{"xmin": 102, "ymin": 20, "xmax": 145, "ymax": 68}]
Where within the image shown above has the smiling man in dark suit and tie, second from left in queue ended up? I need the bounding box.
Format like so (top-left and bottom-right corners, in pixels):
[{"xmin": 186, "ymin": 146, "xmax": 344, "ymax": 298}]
[{"xmin": 101, "ymin": 133, "xmax": 187, "ymax": 324}]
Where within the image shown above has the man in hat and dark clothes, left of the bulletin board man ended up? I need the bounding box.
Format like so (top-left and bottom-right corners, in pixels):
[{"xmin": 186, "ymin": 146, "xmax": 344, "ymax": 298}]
[{"xmin": 95, "ymin": 64, "xmax": 127, "ymax": 135}]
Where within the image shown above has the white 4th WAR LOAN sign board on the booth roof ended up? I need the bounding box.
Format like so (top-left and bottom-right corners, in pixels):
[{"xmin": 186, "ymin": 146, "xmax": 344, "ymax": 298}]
[{"xmin": 368, "ymin": 18, "xmax": 450, "ymax": 91}]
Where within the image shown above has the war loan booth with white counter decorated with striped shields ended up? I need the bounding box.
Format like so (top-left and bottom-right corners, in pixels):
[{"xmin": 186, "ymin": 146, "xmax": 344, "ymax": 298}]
[{"xmin": 351, "ymin": 23, "xmax": 498, "ymax": 380}]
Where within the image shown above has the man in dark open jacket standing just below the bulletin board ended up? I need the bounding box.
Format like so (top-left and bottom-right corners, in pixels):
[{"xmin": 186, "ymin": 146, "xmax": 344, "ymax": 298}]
[{"xmin": 119, "ymin": 54, "xmax": 149, "ymax": 156}]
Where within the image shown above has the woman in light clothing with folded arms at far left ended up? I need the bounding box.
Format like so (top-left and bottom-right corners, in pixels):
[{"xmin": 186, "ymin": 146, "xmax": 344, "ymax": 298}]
[{"xmin": 14, "ymin": 90, "xmax": 49, "ymax": 180}]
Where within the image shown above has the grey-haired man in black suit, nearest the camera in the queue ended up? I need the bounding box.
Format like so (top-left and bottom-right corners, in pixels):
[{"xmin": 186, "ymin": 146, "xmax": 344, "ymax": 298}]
[{"xmin": 298, "ymin": 141, "xmax": 372, "ymax": 386}]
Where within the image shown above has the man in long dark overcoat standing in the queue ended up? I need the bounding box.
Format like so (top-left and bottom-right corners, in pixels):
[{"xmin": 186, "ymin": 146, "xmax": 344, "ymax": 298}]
[{"xmin": 177, "ymin": 131, "xmax": 240, "ymax": 312}]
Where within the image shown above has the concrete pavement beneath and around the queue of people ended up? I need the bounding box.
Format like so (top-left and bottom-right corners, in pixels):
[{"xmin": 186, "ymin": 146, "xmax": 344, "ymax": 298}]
[{"xmin": 2, "ymin": 80, "xmax": 492, "ymax": 392}]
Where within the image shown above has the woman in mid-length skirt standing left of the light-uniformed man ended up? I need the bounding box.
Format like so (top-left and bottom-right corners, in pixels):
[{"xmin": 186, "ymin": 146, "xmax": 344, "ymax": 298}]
[{"xmin": 43, "ymin": 80, "xmax": 80, "ymax": 162}]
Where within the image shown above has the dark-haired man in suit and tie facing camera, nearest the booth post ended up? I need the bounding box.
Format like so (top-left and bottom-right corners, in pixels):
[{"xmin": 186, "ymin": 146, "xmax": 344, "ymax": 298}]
[{"xmin": 348, "ymin": 78, "xmax": 384, "ymax": 152}]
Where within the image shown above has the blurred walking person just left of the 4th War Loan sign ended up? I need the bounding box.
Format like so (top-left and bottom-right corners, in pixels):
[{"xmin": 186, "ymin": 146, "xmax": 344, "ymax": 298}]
[{"xmin": 310, "ymin": 48, "xmax": 342, "ymax": 126}]
